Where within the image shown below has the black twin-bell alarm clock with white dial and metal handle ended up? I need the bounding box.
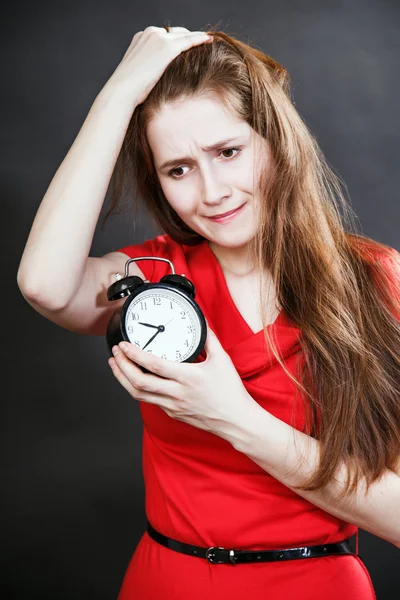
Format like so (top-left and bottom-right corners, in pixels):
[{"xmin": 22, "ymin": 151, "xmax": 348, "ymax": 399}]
[{"xmin": 106, "ymin": 256, "xmax": 207, "ymax": 373}]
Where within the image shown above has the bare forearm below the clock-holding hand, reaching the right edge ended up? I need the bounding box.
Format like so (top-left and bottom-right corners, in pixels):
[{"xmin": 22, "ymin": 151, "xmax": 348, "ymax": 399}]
[{"xmin": 220, "ymin": 402, "xmax": 400, "ymax": 548}]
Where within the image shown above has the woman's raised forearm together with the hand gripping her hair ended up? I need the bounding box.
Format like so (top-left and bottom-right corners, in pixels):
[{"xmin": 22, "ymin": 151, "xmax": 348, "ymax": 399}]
[{"xmin": 17, "ymin": 26, "xmax": 211, "ymax": 311}]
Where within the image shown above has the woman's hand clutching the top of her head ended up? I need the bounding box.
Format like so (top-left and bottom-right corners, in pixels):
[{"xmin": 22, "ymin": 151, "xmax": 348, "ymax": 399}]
[{"xmin": 107, "ymin": 25, "xmax": 213, "ymax": 105}]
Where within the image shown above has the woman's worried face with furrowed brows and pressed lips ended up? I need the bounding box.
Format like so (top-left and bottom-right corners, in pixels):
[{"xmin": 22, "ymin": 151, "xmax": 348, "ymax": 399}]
[{"xmin": 147, "ymin": 97, "xmax": 270, "ymax": 260}]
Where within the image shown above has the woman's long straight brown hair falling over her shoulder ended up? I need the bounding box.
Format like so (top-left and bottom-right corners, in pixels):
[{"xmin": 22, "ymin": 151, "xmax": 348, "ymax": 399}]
[{"xmin": 103, "ymin": 29, "xmax": 400, "ymax": 497}]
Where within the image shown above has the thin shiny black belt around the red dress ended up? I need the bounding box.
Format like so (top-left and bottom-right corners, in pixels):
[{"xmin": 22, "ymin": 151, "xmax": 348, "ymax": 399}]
[{"xmin": 147, "ymin": 519, "xmax": 354, "ymax": 565}]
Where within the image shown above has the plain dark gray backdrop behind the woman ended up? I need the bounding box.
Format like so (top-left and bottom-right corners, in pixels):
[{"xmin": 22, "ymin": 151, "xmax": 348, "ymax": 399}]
[{"xmin": 0, "ymin": 0, "xmax": 400, "ymax": 600}]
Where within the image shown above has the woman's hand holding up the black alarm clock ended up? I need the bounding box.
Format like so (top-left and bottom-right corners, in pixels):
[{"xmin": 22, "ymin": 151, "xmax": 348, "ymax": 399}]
[{"xmin": 109, "ymin": 326, "xmax": 254, "ymax": 437}]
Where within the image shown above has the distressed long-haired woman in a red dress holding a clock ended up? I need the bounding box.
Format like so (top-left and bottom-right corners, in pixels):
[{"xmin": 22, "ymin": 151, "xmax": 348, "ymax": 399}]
[{"xmin": 18, "ymin": 27, "xmax": 400, "ymax": 600}]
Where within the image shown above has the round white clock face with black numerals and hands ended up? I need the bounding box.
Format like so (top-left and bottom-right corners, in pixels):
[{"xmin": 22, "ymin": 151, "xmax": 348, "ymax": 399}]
[{"xmin": 125, "ymin": 288, "xmax": 201, "ymax": 362}]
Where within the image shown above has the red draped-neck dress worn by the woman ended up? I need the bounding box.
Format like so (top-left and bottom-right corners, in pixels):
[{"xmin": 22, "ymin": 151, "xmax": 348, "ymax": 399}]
[{"xmin": 111, "ymin": 235, "xmax": 382, "ymax": 600}]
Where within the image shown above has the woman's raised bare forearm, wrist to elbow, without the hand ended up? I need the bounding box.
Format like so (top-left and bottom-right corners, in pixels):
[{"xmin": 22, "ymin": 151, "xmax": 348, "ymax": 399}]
[{"xmin": 17, "ymin": 84, "xmax": 140, "ymax": 310}]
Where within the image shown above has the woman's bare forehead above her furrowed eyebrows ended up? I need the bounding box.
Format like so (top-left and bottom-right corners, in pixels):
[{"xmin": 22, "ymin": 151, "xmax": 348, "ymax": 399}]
[{"xmin": 146, "ymin": 97, "xmax": 253, "ymax": 161}]
